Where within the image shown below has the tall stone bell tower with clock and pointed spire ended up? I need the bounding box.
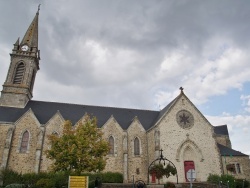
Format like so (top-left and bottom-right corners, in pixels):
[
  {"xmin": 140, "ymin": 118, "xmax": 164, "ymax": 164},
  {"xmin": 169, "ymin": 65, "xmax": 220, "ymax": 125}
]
[{"xmin": 0, "ymin": 7, "xmax": 40, "ymax": 108}]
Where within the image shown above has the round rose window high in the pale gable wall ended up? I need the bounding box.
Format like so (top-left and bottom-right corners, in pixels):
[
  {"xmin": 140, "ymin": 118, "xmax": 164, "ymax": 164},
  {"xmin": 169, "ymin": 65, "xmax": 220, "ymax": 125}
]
[{"xmin": 176, "ymin": 110, "xmax": 194, "ymax": 129}]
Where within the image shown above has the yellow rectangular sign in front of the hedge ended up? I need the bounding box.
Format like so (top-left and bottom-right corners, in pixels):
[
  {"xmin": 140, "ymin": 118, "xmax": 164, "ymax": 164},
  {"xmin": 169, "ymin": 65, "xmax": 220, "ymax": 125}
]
[{"xmin": 68, "ymin": 176, "xmax": 89, "ymax": 188}]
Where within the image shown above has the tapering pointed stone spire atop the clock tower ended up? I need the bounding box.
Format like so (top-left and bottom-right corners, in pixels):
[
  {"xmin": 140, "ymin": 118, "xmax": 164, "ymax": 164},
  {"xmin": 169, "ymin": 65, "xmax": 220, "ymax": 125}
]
[{"xmin": 20, "ymin": 7, "xmax": 40, "ymax": 48}]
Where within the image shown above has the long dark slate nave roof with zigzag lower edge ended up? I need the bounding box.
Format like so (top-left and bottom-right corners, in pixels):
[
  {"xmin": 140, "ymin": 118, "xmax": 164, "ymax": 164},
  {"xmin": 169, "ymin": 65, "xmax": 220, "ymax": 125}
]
[{"xmin": 0, "ymin": 101, "xmax": 160, "ymax": 130}]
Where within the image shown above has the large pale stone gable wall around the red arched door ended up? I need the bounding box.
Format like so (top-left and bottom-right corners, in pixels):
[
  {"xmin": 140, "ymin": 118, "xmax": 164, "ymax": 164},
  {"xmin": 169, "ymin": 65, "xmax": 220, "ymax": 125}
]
[{"xmin": 156, "ymin": 96, "xmax": 221, "ymax": 182}]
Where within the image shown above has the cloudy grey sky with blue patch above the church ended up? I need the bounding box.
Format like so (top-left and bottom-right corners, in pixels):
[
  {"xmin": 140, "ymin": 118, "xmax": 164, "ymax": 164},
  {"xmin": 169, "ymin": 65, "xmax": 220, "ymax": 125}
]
[{"xmin": 0, "ymin": 0, "xmax": 250, "ymax": 155}]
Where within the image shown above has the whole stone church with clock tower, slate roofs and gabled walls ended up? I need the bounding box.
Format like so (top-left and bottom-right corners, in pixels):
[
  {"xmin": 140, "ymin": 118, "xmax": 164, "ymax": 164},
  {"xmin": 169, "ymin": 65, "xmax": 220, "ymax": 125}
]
[{"xmin": 0, "ymin": 9, "xmax": 250, "ymax": 182}]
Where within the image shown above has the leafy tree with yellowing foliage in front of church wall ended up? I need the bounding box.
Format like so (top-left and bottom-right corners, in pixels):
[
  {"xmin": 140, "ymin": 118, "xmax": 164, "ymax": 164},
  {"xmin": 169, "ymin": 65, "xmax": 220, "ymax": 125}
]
[{"xmin": 46, "ymin": 115, "xmax": 109, "ymax": 174}]
